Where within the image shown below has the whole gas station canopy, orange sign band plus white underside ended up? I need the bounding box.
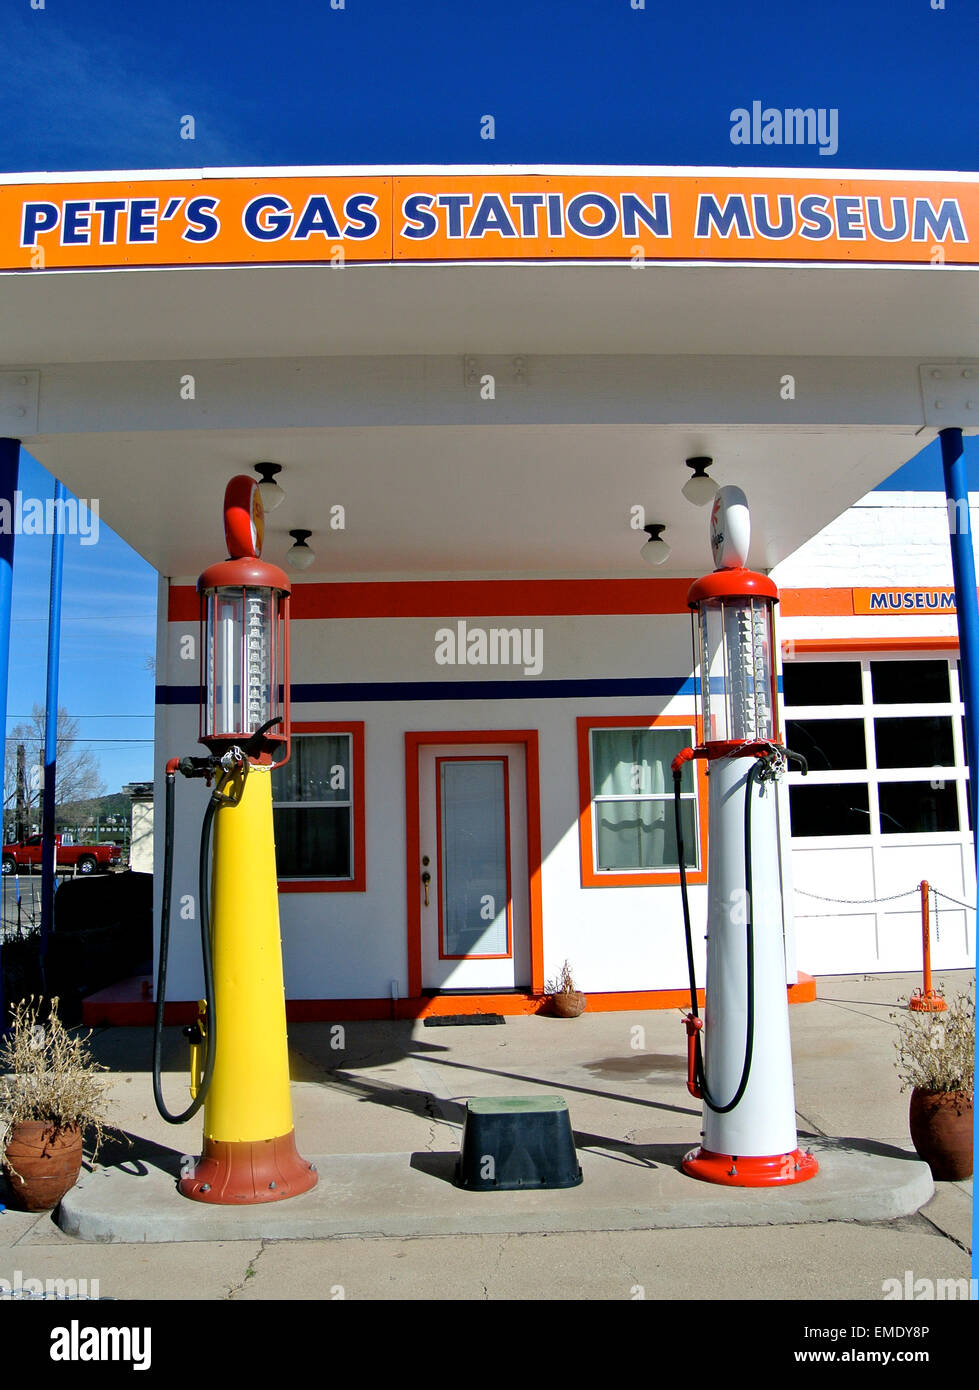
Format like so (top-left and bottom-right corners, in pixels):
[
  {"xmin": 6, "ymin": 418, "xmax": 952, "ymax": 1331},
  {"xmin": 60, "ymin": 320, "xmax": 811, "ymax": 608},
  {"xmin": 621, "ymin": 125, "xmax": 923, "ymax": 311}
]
[{"xmin": 0, "ymin": 168, "xmax": 979, "ymax": 578}]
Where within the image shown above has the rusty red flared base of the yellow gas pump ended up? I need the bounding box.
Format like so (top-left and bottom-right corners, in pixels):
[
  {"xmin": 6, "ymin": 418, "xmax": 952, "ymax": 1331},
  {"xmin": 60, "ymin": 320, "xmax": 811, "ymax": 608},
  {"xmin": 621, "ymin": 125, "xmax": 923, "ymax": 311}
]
[{"xmin": 179, "ymin": 1130, "xmax": 317, "ymax": 1207}]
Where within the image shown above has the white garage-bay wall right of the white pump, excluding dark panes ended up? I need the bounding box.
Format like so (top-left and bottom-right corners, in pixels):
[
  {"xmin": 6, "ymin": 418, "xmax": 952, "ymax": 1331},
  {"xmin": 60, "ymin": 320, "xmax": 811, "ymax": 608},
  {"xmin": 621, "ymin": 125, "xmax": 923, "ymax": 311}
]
[{"xmin": 772, "ymin": 492, "xmax": 979, "ymax": 974}]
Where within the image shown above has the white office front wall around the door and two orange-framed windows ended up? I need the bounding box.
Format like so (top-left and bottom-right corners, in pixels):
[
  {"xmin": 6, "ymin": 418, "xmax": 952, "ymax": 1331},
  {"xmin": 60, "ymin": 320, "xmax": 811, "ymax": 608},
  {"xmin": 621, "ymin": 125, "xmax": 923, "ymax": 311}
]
[{"xmin": 157, "ymin": 594, "xmax": 706, "ymax": 999}]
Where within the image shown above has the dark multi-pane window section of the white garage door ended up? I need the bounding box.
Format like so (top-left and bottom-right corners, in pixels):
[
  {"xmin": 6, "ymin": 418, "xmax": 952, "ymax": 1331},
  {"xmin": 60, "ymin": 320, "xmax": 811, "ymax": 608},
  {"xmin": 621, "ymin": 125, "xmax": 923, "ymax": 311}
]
[{"xmin": 783, "ymin": 655, "xmax": 971, "ymax": 842}]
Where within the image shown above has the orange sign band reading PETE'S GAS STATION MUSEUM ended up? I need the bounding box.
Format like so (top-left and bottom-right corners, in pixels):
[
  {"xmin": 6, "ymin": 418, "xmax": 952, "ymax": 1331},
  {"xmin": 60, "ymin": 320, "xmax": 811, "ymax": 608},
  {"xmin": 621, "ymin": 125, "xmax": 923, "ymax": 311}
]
[{"xmin": 0, "ymin": 170, "xmax": 979, "ymax": 271}]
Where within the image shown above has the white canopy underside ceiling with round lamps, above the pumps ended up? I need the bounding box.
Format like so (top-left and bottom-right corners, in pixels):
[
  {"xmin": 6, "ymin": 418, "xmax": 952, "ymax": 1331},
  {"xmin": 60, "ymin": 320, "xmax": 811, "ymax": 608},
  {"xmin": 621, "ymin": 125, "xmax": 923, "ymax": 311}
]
[{"xmin": 31, "ymin": 425, "xmax": 922, "ymax": 580}]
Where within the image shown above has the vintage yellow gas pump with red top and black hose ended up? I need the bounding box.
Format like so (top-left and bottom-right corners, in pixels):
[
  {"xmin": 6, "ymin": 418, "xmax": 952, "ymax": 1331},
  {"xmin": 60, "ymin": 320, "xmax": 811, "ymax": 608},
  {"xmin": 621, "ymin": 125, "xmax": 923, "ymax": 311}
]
[{"xmin": 153, "ymin": 475, "xmax": 317, "ymax": 1205}]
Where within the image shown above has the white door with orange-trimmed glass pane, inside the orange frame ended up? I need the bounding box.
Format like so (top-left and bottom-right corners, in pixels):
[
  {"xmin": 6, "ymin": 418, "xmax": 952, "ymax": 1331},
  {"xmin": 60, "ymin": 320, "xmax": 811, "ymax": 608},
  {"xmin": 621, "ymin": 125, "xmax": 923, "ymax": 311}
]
[{"xmin": 419, "ymin": 744, "xmax": 530, "ymax": 990}]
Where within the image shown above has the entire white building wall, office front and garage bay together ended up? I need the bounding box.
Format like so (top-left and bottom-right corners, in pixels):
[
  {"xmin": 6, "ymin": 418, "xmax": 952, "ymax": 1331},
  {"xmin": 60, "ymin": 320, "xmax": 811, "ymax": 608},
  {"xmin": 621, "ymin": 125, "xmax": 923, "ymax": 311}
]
[{"xmin": 148, "ymin": 492, "xmax": 979, "ymax": 999}]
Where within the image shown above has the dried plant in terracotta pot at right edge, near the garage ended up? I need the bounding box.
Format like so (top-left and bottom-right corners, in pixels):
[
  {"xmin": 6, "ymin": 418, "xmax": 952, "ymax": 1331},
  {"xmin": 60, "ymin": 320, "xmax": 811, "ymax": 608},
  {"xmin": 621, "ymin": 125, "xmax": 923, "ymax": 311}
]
[{"xmin": 891, "ymin": 986, "xmax": 976, "ymax": 1183}]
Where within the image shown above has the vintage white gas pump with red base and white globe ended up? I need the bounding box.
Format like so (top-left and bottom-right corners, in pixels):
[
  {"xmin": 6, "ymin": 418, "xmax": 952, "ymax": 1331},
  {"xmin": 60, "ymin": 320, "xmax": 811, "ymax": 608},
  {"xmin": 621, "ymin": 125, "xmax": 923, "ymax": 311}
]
[{"xmin": 673, "ymin": 487, "xmax": 818, "ymax": 1187}]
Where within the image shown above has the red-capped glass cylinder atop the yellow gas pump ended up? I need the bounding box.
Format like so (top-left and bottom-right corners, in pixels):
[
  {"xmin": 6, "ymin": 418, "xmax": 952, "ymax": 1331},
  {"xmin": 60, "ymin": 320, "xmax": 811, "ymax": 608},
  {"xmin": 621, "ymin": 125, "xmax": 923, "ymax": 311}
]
[{"xmin": 197, "ymin": 559, "xmax": 289, "ymax": 766}]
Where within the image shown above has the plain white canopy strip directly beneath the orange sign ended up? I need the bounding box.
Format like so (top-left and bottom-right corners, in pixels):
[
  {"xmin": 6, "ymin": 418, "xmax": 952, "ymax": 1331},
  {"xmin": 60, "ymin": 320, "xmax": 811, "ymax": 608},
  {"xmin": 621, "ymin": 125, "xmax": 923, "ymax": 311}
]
[{"xmin": 0, "ymin": 264, "xmax": 979, "ymax": 366}]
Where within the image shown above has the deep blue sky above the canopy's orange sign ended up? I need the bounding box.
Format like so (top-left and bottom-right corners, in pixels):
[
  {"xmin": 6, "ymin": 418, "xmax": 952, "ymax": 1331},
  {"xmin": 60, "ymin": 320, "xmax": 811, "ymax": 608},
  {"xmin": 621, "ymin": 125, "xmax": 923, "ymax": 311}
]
[{"xmin": 0, "ymin": 0, "xmax": 979, "ymax": 172}]
